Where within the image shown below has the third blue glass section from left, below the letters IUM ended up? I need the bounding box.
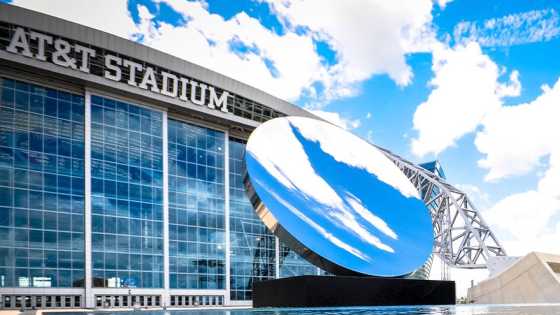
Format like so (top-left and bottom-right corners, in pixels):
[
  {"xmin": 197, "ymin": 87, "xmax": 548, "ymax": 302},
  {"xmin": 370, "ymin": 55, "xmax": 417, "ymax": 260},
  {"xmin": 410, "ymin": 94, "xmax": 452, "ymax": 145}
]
[{"xmin": 168, "ymin": 120, "xmax": 226, "ymax": 289}]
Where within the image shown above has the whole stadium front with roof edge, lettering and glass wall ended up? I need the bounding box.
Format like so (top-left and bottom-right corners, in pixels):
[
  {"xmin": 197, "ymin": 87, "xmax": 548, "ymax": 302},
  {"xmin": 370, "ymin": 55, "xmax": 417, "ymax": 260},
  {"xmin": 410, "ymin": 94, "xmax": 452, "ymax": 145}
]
[{"xmin": 0, "ymin": 4, "xmax": 321, "ymax": 308}]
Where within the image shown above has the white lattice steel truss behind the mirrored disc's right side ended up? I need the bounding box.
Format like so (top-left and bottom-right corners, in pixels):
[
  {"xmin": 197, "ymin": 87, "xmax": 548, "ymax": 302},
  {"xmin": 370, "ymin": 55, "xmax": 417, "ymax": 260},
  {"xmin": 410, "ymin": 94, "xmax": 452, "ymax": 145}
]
[{"xmin": 379, "ymin": 148, "xmax": 506, "ymax": 269}]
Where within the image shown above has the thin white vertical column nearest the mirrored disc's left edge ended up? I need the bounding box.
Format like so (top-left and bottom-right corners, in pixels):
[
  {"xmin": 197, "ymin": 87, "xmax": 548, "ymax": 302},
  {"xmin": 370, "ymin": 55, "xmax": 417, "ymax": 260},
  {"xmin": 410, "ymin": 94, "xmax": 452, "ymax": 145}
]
[{"xmin": 224, "ymin": 131, "xmax": 231, "ymax": 305}]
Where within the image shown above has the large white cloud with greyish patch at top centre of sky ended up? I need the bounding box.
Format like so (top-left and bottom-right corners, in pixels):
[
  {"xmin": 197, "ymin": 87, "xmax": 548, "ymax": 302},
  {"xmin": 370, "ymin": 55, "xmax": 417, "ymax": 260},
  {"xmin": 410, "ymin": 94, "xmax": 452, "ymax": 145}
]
[{"xmin": 266, "ymin": 0, "xmax": 435, "ymax": 100}]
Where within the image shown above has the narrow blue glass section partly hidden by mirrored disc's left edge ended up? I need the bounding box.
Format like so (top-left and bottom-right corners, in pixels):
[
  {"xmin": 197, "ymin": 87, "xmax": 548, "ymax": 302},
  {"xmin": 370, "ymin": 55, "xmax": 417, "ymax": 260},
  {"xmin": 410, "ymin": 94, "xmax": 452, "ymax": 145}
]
[{"xmin": 229, "ymin": 138, "xmax": 275, "ymax": 300}]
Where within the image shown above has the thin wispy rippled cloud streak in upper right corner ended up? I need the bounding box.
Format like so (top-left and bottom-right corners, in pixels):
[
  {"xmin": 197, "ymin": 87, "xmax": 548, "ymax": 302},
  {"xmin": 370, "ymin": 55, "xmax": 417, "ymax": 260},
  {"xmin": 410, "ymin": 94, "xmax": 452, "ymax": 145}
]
[{"xmin": 453, "ymin": 9, "xmax": 560, "ymax": 47}]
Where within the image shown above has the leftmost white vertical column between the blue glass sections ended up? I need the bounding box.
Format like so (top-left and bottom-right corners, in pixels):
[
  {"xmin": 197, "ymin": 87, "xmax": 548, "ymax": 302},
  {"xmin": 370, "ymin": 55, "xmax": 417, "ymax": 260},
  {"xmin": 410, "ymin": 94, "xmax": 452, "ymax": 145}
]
[{"xmin": 84, "ymin": 89, "xmax": 95, "ymax": 308}]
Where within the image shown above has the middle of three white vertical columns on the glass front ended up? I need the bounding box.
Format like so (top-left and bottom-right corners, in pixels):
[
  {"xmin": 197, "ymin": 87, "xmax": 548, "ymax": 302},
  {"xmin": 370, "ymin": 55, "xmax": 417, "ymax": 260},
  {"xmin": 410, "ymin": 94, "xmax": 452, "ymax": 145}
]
[{"xmin": 161, "ymin": 111, "xmax": 169, "ymax": 307}]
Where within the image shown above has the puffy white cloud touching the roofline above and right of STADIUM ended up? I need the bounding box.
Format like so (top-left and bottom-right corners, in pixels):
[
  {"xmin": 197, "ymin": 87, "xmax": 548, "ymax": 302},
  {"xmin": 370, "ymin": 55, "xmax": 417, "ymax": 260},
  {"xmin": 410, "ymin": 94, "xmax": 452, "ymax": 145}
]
[{"xmin": 135, "ymin": 0, "xmax": 326, "ymax": 101}]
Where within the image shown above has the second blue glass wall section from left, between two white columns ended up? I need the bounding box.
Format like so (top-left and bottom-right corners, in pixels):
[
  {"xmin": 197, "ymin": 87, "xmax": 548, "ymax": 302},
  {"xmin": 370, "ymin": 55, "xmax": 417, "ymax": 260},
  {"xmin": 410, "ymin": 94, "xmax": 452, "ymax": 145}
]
[{"xmin": 91, "ymin": 96, "xmax": 163, "ymax": 288}]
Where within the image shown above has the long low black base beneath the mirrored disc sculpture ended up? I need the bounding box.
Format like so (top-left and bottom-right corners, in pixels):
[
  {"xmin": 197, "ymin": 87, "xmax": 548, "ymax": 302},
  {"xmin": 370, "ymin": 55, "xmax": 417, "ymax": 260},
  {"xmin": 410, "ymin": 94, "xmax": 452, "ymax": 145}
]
[{"xmin": 253, "ymin": 276, "xmax": 455, "ymax": 307}]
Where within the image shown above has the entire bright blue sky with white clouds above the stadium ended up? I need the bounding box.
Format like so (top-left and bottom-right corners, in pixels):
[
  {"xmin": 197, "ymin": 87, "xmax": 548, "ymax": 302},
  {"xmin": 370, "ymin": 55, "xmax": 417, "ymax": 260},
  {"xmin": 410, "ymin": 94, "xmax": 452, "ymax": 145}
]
[{"xmin": 4, "ymin": 0, "xmax": 560, "ymax": 298}]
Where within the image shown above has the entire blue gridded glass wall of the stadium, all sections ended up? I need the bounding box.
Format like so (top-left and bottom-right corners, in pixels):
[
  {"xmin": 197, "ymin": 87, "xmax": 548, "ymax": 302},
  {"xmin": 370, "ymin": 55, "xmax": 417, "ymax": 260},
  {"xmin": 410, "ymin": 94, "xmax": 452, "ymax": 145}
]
[{"xmin": 0, "ymin": 75, "xmax": 316, "ymax": 301}]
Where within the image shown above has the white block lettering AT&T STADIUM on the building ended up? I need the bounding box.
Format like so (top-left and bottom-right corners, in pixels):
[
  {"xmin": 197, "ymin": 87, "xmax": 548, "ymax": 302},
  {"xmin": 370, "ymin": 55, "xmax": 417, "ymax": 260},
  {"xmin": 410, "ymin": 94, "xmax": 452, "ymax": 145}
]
[{"xmin": 6, "ymin": 27, "xmax": 230, "ymax": 113}]
